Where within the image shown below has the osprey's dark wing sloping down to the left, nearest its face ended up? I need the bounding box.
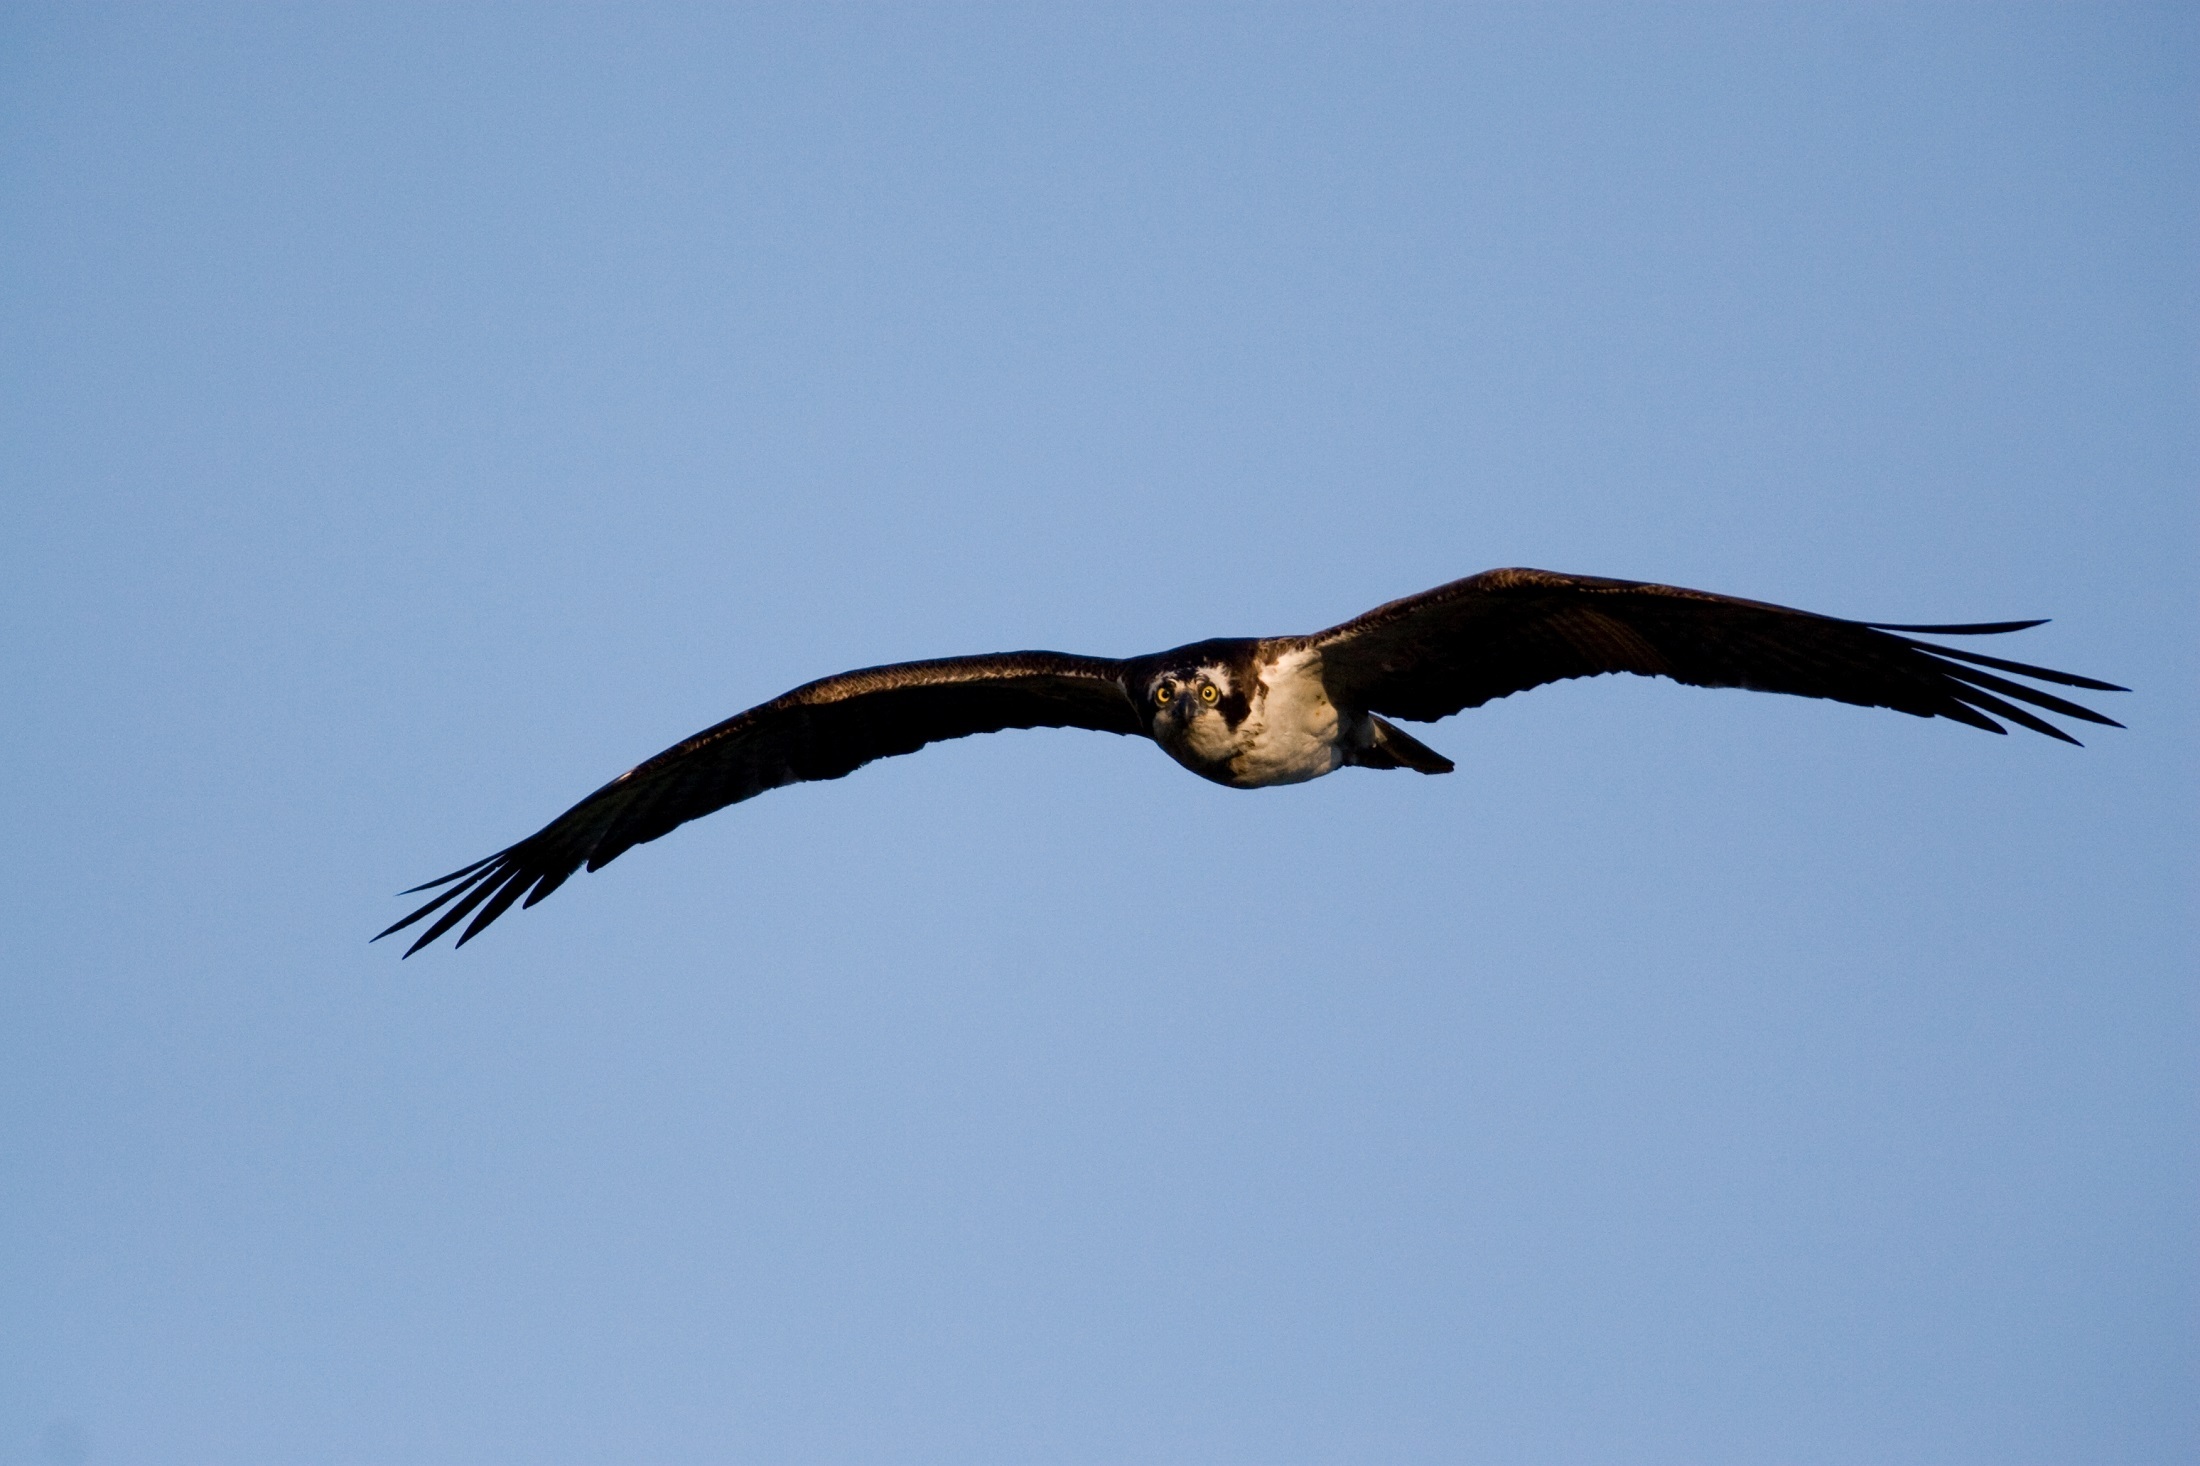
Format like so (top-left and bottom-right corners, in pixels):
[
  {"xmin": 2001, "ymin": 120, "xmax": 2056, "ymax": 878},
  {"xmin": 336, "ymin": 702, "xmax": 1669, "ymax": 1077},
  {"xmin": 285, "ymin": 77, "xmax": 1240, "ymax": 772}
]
[{"xmin": 374, "ymin": 652, "xmax": 1144, "ymax": 958}]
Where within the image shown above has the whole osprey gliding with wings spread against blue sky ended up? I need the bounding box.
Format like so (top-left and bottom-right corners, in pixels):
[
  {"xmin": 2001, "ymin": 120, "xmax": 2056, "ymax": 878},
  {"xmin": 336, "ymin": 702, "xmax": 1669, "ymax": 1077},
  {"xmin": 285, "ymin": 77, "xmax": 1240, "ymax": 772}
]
[{"xmin": 374, "ymin": 570, "xmax": 2125, "ymax": 958}]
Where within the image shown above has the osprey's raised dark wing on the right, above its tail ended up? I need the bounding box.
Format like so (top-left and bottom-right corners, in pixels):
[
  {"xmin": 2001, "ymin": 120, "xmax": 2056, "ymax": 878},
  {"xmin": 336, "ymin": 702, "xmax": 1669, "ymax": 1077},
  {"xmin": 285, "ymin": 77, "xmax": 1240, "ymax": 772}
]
[{"xmin": 1305, "ymin": 570, "xmax": 2125, "ymax": 744}]
